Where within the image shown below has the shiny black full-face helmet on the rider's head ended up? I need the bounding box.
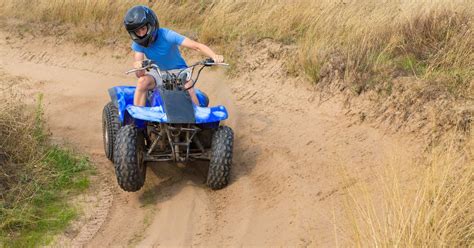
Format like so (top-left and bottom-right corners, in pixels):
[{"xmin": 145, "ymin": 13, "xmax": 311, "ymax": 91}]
[{"xmin": 123, "ymin": 5, "xmax": 160, "ymax": 47}]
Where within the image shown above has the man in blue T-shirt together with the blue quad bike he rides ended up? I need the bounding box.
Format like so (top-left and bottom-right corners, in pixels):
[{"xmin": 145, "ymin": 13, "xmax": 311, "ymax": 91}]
[{"xmin": 102, "ymin": 6, "xmax": 233, "ymax": 191}]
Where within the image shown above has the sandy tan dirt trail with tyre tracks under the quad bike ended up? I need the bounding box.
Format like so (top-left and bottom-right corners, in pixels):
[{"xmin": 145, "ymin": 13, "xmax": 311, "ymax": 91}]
[{"xmin": 0, "ymin": 33, "xmax": 414, "ymax": 247}]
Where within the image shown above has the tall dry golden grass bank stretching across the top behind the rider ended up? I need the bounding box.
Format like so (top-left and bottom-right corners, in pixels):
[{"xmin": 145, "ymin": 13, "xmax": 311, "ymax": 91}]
[{"xmin": 0, "ymin": 0, "xmax": 474, "ymax": 97}]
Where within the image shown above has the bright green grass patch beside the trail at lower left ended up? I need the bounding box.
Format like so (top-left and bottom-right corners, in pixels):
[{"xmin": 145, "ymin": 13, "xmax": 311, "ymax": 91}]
[{"xmin": 0, "ymin": 146, "xmax": 92, "ymax": 247}]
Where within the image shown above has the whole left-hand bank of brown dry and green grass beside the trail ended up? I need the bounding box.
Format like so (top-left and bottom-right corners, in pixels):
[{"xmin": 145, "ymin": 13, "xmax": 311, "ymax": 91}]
[{"xmin": 0, "ymin": 79, "xmax": 91, "ymax": 247}]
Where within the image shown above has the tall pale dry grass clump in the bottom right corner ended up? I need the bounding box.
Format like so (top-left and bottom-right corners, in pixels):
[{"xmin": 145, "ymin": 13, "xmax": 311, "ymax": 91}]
[{"xmin": 347, "ymin": 140, "xmax": 474, "ymax": 247}]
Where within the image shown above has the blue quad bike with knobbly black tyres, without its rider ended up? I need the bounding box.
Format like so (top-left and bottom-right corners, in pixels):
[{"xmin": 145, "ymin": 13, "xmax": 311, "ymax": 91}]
[{"xmin": 102, "ymin": 59, "xmax": 234, "ymax": 192}]
